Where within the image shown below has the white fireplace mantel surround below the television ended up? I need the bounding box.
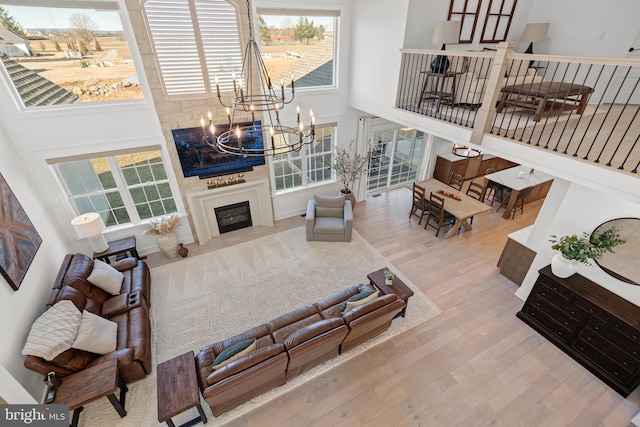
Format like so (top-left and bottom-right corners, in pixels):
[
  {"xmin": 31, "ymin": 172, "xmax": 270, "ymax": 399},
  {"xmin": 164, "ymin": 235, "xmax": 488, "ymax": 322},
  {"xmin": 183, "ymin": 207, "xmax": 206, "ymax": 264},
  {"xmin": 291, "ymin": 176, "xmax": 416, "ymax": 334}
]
[{"xmin": 186, "ymin": 178, "xmax": 273, "ymax": 245}]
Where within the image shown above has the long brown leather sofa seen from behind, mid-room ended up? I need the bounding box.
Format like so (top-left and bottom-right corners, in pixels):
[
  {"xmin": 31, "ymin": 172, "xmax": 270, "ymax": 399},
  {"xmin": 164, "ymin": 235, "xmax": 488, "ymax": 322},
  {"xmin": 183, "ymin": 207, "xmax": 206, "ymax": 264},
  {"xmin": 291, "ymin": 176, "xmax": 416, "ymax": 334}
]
[{"xmin": 196, "ymin": 284, "xmax": 405, "ymax": 416}]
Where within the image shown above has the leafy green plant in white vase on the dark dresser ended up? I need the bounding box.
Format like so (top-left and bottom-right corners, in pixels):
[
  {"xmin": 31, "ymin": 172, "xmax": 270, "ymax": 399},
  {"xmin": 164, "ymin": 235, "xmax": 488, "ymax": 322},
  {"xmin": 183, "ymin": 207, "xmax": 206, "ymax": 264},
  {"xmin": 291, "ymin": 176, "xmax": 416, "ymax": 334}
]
[{"xmin": 549, "ymin": 227, "xmax": 626, "ymax": 278}]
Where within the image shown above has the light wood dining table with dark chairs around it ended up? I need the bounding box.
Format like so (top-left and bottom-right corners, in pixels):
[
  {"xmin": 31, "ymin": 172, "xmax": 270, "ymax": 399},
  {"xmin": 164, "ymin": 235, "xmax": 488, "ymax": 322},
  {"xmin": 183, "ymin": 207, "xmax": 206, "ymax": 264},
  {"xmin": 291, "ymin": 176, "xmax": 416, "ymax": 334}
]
[{"xmin": 416, "ymin": 178, "xmax": 491, "ymax": 239}]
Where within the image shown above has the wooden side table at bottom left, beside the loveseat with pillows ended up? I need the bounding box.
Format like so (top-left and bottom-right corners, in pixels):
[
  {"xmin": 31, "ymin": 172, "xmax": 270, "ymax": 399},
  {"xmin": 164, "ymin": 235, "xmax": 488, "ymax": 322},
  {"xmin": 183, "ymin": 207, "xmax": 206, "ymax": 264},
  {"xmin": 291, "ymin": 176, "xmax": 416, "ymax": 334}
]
[{"xmin": 52, "ymin": 359, "xmax": 129, "ymax": 427}]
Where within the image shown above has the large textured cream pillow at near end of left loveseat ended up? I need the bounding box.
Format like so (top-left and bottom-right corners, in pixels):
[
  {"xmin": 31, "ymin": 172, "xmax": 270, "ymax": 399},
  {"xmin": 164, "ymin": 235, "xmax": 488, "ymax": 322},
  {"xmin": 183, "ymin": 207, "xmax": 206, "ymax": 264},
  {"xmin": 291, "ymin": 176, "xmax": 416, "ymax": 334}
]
[{"xmin": 22, "ymin": 300, "xmax": 82, "ymax": 360}]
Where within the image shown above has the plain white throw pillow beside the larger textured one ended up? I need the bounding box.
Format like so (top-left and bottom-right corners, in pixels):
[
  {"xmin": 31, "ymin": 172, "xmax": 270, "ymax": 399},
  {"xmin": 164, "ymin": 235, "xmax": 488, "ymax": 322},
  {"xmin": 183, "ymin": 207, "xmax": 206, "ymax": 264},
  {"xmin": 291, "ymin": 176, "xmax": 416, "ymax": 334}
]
[{"xmin": 71, "ymin": 310, "xmax": 118, "ymax": 354}]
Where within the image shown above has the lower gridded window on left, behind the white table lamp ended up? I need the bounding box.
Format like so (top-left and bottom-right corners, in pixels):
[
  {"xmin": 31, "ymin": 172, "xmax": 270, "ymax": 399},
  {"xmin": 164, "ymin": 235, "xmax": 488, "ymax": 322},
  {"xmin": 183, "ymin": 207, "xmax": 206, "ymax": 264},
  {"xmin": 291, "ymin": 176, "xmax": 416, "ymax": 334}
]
[{"xmin": 53, "ymin": 150, "xmax": 177, "ymax": 227}]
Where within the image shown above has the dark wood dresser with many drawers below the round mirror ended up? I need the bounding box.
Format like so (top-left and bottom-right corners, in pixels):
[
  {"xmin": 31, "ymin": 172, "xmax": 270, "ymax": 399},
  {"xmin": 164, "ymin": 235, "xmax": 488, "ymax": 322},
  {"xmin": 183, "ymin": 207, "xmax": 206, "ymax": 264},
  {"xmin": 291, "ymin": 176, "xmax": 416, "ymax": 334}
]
[{"xmin": 517, "ymin": 266, "xmax": 640, "ymax": 397}]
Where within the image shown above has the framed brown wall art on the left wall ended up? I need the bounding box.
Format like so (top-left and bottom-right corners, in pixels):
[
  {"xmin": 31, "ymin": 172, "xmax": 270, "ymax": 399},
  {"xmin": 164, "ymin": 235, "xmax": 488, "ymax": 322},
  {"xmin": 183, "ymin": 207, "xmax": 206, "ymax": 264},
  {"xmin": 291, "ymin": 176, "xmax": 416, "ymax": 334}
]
[{"xmin": 0, "ymin": 174, "xmax": 42, "ymax": 291}]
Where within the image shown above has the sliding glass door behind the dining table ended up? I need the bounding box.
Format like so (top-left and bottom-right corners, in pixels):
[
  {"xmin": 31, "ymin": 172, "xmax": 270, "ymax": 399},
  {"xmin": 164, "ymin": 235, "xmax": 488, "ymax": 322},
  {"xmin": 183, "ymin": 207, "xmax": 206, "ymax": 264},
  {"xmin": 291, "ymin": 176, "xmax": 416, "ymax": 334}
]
[{"xmin": 367, "ymin": 128, "xmax": 424, "ymax": 192}]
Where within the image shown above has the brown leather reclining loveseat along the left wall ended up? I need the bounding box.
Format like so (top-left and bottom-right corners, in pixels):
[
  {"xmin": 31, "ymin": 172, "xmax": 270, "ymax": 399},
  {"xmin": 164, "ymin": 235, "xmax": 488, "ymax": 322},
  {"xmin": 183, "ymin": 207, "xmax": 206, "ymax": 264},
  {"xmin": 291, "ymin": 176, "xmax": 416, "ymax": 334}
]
[{"xmin": 24, "ymin": 254, "xmax": 151, "ymax": 384}]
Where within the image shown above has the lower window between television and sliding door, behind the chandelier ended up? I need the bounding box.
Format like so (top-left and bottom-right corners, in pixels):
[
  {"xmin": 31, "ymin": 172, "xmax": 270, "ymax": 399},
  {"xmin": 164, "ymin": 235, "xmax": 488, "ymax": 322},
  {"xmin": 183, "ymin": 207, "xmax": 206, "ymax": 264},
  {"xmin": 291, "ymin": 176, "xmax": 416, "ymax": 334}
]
[{"xmin": 273, "ymin": 124, "xmax": 336, "ymax": 191}]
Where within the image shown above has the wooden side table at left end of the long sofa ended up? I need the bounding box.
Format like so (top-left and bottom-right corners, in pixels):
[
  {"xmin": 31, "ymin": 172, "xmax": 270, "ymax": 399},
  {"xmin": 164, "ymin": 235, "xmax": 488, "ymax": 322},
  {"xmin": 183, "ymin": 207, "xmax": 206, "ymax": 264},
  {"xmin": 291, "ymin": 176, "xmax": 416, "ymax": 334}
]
[{"xmin": 157, "ymin": 351, "xmax": 207, "ymax": 427}]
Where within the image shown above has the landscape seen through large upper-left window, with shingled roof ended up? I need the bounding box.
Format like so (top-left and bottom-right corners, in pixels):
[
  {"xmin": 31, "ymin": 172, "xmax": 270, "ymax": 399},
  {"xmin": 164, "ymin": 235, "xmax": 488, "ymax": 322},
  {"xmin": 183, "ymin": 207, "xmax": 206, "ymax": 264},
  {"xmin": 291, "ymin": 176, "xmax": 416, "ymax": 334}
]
[{"xmin": 0, "ymin": 4, "xmax": 143, "ymax": 107}]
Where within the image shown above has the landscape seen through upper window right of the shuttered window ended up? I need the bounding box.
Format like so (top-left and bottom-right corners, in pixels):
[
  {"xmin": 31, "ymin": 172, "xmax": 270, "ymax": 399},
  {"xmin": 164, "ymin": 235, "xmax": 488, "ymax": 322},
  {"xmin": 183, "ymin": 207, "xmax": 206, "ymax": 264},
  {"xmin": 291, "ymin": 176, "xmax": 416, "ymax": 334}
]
[{"xmin": 258, "ymin": 11, "xmax": 337, "ymax": 88}]
